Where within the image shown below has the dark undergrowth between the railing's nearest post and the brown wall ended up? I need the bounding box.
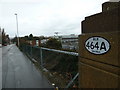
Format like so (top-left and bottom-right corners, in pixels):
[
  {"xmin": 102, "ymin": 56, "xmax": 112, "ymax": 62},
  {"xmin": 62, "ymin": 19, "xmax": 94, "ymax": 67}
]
[{"xmin": 43, "ymin": 50, "xmax": 78, "ymax": 88}]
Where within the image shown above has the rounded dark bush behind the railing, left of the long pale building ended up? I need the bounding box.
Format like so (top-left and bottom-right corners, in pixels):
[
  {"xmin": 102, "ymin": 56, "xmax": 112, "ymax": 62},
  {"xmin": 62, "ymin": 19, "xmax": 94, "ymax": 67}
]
[{"xmin": 45, "ymin": 38, "xmax": 62, "ymax": 49}]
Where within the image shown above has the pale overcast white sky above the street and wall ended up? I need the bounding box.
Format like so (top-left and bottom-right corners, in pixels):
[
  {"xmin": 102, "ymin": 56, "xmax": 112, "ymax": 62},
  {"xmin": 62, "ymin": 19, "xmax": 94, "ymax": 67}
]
[{"xmin": 0, "ymin": 0, "xmax": 108, "ymax": 37}]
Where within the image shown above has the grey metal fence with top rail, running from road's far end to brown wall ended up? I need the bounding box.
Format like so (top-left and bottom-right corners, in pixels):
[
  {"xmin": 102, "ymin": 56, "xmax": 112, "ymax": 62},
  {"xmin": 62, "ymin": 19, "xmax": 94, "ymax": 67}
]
[{"xmin": 20, "ymin": 45, "xmax": 79, "ymax": 88}]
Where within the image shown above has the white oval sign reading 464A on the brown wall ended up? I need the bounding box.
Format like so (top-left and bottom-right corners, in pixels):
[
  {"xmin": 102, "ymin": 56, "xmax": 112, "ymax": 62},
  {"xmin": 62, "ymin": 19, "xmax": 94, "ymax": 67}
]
[{"xmin": 85, "ymin": 37, "xmax": 110, "ymax": 55}]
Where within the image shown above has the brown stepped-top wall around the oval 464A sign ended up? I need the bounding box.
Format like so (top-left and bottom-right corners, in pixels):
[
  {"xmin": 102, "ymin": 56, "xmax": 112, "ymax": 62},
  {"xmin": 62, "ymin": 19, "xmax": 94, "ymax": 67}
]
[{"xmin": 79, "ymin": 2, "xmax": 120, "ymax": 88}]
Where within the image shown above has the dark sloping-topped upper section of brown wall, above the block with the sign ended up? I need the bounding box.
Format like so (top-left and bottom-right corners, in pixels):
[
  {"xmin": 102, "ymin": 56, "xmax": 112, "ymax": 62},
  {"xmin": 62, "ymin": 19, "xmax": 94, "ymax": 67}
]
[{"xmin": 82, "ymin": 3, "xmax": 120, "ymax": 33}]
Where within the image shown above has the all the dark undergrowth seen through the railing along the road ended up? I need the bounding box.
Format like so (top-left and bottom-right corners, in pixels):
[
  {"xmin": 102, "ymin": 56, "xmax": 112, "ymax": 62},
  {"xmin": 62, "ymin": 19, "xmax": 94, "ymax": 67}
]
[{"xmin": 20, "ymin": 45, "xmax": 78, "ymax": 88}]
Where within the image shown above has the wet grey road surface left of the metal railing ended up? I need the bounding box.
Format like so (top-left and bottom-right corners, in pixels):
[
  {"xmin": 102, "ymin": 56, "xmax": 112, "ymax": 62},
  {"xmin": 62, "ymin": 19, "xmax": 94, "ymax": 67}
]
[{"xmin": 2, "ymin": 44, "xmax": 53, "ymax": 88}]
